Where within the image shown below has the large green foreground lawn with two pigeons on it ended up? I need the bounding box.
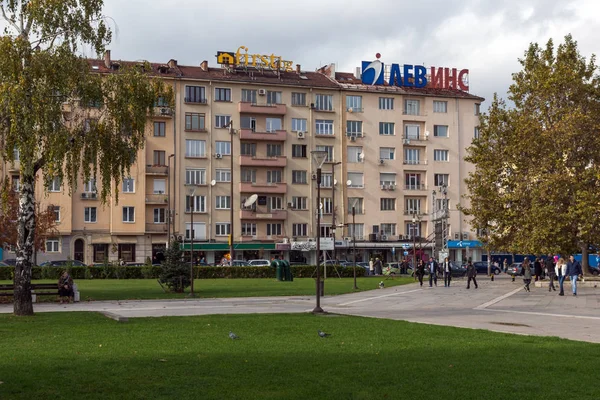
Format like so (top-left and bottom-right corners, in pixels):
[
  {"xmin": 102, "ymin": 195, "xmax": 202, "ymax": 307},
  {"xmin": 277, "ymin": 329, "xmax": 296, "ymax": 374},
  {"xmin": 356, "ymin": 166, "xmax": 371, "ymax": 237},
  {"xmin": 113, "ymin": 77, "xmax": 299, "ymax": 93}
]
[{"xmin": 0, "ymin": 313, "xmax": 600, "ymax": 400}]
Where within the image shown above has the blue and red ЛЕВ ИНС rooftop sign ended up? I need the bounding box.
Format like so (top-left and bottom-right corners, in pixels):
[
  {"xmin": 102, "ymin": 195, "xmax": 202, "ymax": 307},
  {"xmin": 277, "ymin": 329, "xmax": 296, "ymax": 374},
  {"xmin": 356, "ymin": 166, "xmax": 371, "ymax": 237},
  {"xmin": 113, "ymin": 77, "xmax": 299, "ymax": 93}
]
[{"xmin": 361, "ymin": 53, "xmax": 469, "ymax": 92}]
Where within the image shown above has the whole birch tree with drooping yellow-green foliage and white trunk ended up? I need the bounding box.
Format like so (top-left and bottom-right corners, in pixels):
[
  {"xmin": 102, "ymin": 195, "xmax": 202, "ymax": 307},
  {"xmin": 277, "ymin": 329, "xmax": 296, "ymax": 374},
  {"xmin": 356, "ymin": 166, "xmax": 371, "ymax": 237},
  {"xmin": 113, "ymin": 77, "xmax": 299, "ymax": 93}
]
[{"xmin": 0, "ymin": 0, "xmax": 172, "ymax": 315}]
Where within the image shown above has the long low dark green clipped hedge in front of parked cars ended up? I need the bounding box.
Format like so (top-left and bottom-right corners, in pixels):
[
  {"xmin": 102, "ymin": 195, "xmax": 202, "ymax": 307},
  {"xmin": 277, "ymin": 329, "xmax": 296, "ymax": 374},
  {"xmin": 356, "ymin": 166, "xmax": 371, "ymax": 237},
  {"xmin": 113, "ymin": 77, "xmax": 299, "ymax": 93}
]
[{"xmin": 0, "ymin": 265, "xmax": 364, "ymax": 280}]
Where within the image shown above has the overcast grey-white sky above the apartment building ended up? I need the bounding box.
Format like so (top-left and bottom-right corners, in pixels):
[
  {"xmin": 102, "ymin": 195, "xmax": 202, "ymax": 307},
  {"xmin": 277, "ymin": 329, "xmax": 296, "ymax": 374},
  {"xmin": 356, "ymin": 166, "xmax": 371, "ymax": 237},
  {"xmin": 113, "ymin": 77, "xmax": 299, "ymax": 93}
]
[{"xmin": 96, "ymin": 0, "xmax": 600, "ymax": 105}]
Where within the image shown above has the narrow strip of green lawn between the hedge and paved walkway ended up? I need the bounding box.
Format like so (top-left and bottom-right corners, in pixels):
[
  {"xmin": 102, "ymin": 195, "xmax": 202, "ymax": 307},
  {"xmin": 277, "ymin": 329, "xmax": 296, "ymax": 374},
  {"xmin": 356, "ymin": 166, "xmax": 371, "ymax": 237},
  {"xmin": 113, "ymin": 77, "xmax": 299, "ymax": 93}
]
[{"xmin": 0, "ymin": 277, "xmax": 414, "ymax": 301}]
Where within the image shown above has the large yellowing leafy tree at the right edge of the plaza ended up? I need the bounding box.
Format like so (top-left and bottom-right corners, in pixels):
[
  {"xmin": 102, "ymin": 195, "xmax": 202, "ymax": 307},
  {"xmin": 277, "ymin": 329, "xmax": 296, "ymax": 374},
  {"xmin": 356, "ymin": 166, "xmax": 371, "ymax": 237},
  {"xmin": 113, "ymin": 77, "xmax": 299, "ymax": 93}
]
[{"xmin": 463, "ymin": 35, "xmax": 600, "ymax": 273}]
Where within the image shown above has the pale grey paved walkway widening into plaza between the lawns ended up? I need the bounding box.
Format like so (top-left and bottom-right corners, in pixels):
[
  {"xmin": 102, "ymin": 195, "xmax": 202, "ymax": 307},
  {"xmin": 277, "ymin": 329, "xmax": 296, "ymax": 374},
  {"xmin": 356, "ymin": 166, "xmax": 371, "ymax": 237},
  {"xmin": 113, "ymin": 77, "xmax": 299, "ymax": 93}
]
[{"xmin": 0, "ymin": 277, "xmax": 600, "ymax": 343}]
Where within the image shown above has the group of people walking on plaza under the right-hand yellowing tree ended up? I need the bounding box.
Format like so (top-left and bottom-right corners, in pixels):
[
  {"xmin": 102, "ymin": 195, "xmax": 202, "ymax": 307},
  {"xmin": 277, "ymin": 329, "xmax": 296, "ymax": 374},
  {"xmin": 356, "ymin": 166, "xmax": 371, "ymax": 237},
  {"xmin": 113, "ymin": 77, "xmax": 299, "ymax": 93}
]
[{"xmin": 521, "ymin": 254, "xmax": 583, "ymax": 296}]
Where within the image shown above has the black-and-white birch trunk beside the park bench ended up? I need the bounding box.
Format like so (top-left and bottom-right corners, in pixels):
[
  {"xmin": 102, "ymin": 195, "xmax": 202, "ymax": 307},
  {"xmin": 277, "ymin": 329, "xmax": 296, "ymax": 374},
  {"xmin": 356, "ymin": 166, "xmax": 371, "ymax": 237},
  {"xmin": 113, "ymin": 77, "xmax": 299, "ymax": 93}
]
[{"xmin": 14, "ymin": 174, "xmax": 35, "ymax": 315}]
